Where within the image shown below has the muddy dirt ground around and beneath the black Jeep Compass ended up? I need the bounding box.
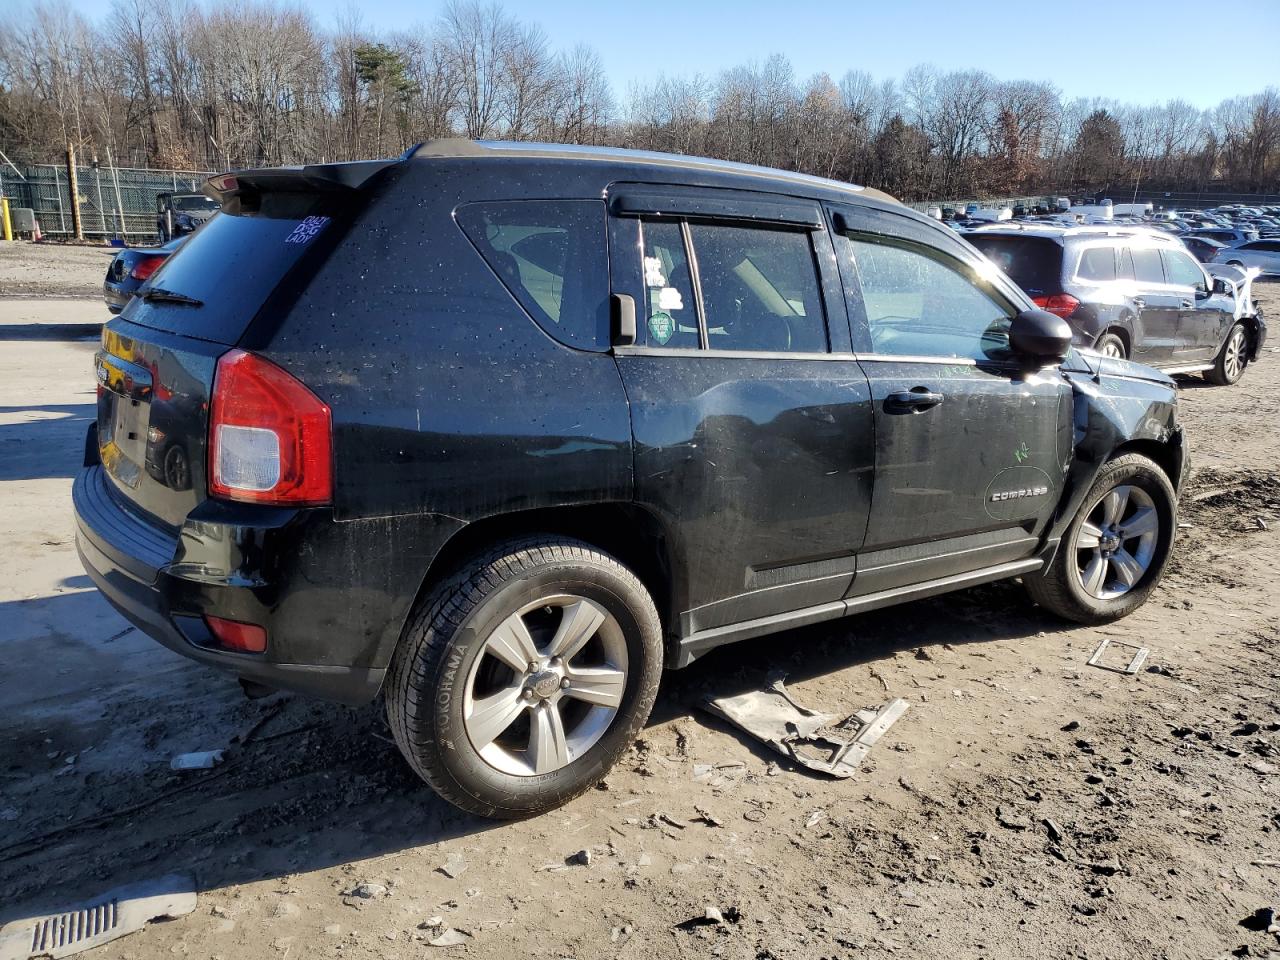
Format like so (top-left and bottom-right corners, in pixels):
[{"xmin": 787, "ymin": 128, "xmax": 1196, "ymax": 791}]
[{"xmin": 0, "ymin": 248, "xmax": 1280, "ymax": 960}]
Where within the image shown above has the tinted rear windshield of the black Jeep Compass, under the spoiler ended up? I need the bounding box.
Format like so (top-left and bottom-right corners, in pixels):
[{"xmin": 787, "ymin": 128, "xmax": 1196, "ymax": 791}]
[{"xmin": 124, "ymin": 193, "xmax": 344, "ymax": 343}]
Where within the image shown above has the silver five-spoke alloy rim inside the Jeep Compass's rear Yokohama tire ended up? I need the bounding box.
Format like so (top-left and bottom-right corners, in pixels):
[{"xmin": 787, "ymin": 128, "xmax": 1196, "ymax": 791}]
[{"xmin": 462, "ymin": 594, "xmax": 627, "ymax": 777}]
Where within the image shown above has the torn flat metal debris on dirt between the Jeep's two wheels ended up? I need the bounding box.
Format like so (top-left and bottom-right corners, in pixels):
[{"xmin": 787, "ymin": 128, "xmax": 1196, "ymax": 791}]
[{"xmin": 703, "ymin": 677, "xmax": 910, "ymax": 778}]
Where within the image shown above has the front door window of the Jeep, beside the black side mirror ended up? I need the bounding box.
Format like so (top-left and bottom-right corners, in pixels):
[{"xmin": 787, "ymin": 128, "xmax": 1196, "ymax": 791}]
[{"xmin": 842, "ymin": 238, "xmax": 1014, "ymax": 360}]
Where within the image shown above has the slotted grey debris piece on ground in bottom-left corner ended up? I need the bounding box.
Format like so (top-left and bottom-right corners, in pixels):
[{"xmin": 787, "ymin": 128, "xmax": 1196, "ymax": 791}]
[{"xmin": 0, "ymin": 873, "xmax": 196, "ymax": 960}]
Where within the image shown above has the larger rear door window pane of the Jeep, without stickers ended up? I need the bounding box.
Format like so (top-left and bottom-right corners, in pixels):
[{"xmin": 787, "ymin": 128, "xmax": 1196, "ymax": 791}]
[{"xmin": 689, "ymin": 224, "xmax": 827, "ymax": 353}]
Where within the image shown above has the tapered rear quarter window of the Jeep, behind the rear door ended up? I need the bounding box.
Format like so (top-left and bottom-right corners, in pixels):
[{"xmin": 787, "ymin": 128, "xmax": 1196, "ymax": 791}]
[{"xmin": 457, "ymin": 200, "xmax": 609, "ymax": 351}]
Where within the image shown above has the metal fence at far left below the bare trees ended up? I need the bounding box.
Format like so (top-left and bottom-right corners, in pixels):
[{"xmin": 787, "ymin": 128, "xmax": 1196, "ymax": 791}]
[{"xmin": 0, "ymin": 164, "xmax": 210, "ymax": 241}]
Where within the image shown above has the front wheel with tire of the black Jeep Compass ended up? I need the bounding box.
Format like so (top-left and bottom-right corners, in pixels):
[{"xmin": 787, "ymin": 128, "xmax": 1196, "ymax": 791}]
[{"xmin": 1024, "ymin": 453, "xmax": 1178, "ymax": 625}]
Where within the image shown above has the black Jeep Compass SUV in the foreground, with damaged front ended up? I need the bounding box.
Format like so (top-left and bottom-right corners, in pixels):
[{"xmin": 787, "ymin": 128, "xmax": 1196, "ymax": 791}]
[{"xmin": 73, "ymin": 141, "xmax": 1185, "ymax": 817}]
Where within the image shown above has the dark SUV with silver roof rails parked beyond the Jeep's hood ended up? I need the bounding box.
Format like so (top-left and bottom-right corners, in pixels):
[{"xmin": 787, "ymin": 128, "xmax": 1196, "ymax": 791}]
[{"xmin": 966, "ymin": 225, "xmax": 1266, "ymax": 385}]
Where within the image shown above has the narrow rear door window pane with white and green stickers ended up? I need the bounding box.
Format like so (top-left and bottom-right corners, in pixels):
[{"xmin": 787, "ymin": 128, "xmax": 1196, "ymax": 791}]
[{"xmin": 636, "ymin": 220, "xmax": 700, "ymax": 349}]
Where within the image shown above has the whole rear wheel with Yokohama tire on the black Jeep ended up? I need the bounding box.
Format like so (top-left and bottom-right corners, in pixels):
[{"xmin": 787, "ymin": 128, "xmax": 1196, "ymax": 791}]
[{"xmin": 387, "ymin": 536, "xmax": 663, "ymax": 819}]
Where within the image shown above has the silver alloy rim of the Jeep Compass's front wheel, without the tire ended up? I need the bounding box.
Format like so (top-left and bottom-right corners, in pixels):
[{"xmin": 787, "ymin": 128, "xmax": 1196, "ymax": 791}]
[{"xmin": 1075, "ymin": 484, "xmax": 1160, "ymax": 600}]
